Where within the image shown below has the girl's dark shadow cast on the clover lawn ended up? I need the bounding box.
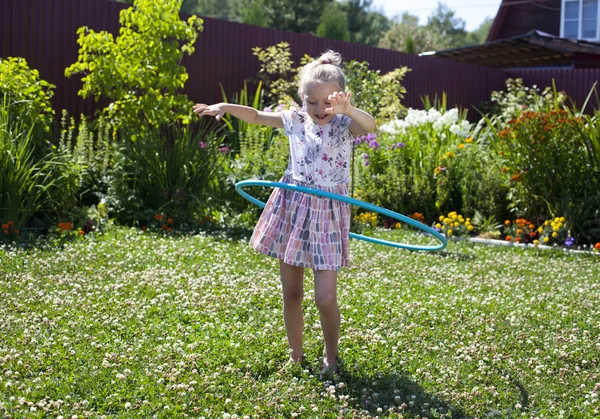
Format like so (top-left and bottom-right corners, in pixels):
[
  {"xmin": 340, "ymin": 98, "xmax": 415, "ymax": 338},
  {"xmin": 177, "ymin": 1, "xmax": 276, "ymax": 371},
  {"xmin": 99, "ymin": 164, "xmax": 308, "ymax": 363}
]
[{"xmin": 339, "ymin": 362, "xmax": 469, "ymax": 419}]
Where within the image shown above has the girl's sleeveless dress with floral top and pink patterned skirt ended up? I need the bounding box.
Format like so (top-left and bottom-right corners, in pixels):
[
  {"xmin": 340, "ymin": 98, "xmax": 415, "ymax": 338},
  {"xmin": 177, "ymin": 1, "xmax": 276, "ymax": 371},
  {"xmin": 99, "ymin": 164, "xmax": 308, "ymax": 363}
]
[{"xmin": 250, "ymin": 109, "xmax": 353, "ymax": 271}]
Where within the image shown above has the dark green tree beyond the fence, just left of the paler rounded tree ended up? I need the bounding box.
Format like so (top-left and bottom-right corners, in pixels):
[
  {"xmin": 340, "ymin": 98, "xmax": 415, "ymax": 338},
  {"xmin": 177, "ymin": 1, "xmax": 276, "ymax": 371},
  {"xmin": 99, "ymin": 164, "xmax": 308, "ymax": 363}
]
[{"xmin": 340, "ymin": 0, "xmax": 390, "ymax": 46}]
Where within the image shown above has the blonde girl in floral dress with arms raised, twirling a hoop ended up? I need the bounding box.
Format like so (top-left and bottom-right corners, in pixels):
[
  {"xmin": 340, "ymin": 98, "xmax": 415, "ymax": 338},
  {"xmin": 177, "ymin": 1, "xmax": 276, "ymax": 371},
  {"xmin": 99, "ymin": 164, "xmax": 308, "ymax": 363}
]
[{"xmin": 194, "ymin": 51, "xmax": 375, "ymax": 374}]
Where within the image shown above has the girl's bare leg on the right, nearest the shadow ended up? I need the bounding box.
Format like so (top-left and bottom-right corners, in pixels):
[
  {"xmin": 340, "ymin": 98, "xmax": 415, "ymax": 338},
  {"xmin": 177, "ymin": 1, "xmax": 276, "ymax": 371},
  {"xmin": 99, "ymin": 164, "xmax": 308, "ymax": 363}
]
[{"xmin": 314, "ymin": 270, "xmax": 340, "ymax": 372}]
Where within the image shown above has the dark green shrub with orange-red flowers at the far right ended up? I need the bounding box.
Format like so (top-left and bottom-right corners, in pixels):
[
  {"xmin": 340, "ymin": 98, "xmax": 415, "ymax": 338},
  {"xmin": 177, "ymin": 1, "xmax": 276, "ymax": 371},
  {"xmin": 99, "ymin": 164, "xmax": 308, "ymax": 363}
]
[{"xmin": 493, "ymin": 110, "xmax": 596, "ymax": 240}]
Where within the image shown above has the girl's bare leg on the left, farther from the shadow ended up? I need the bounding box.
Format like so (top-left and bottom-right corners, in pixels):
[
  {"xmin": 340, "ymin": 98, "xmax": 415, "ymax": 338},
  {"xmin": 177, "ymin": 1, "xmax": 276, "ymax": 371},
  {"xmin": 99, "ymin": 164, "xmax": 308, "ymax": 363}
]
[{"xmin": 279, "ymin": 260, "xmax": 304, "ymax": 362}]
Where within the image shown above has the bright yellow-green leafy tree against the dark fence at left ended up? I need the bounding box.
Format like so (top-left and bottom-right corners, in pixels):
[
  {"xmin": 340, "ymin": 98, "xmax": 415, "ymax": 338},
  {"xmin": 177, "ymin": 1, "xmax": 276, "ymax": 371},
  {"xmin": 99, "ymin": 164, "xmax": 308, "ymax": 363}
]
[{"xmin": 65, "ymin": 0, "xmax": 202, "ymax": 135}]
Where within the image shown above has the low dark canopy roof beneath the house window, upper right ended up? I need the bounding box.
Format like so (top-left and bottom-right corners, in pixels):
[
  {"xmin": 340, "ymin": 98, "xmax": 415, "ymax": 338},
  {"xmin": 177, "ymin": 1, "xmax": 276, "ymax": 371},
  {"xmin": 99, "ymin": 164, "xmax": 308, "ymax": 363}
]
[{"xmin": 421, "ymin": 30, "xmax": 600, "ymax": 68}]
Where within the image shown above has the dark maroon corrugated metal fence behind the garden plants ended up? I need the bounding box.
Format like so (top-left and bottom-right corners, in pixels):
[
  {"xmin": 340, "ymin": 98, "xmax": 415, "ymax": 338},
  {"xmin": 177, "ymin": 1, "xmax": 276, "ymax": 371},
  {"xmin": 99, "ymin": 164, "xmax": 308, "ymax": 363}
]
[{"xmin": 0, "ymin": 0, "xmax": 600, "ymax": 121}]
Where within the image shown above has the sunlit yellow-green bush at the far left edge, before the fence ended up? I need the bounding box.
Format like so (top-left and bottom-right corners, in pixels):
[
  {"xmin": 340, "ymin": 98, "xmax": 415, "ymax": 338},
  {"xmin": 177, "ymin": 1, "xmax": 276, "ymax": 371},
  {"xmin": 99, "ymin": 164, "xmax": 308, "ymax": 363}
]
[{"xmin": 0, "ymin": 57, "xmax": 56, "ymax": 132}]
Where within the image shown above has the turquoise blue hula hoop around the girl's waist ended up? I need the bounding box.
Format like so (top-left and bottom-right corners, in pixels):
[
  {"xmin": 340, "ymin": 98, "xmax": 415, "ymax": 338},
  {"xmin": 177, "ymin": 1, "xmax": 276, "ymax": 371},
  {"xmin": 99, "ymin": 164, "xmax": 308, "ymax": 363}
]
[{"xmin": 235, "ymin": 180, "xmax": 448, "ymax": 251}]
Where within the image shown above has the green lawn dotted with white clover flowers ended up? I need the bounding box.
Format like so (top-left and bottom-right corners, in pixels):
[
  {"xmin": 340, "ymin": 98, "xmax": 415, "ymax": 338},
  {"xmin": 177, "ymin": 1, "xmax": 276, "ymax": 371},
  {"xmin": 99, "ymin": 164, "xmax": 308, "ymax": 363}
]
[{"xmin": 0, "ymin": 229, "xmax": 600, "ymax": 418}]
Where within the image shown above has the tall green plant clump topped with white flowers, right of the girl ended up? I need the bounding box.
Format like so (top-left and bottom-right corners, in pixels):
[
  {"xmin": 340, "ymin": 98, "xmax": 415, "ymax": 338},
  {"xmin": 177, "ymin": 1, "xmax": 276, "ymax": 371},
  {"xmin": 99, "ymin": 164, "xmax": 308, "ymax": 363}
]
[{"xmin": 355, "ymin": 108, "xmax": 478, "ymax": 218}]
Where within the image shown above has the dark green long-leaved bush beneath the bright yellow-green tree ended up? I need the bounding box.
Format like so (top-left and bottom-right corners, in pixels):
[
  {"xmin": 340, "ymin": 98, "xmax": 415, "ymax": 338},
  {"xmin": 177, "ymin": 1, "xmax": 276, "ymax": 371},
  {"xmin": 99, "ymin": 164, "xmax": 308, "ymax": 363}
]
[{"xmin": 113, "ymin": 124, "xmax": 229, "ymax": 225}]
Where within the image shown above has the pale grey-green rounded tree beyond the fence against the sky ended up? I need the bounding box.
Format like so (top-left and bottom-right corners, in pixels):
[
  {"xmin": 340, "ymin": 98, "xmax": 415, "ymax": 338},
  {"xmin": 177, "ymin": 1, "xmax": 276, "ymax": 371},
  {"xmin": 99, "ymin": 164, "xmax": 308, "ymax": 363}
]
[{"xmin": 379, "ymin": 12, "xmax": 449, "ymax": 54}]
